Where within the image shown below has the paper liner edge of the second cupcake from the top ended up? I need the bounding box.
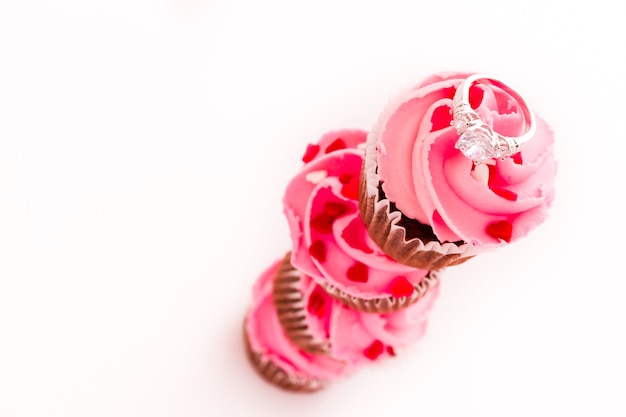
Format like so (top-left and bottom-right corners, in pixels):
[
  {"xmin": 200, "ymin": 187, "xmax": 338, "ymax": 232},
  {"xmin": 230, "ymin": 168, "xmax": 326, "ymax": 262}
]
[{"xmin": 322, "ymin": 271, "xmax": 439, "ymax": 314}]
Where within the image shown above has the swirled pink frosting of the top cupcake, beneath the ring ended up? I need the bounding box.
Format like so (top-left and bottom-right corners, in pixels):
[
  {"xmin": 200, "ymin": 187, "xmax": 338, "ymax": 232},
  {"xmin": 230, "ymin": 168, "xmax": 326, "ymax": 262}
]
[{"xmin": 371, "ymin": 74, "xmax": 556, "ymax": 248}]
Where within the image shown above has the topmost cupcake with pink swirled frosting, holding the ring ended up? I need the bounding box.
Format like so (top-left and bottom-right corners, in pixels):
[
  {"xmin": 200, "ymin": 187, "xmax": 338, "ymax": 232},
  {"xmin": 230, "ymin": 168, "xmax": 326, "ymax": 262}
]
[{"xmin": 359, "ymin": 73, "xmax": 556, "ymax": 270}]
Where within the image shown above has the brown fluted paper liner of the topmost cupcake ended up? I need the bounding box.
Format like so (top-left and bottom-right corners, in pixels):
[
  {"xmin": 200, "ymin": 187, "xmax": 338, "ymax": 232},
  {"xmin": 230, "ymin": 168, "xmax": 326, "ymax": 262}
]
[{"xmin": 359, "ymin": 132, "xmax": 481, "ymax": 270}]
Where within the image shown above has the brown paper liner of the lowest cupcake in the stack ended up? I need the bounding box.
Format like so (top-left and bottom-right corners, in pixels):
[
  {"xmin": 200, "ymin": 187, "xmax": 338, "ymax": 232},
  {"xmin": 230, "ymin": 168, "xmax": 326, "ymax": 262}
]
[{"xmin": 243, "ymin": 324, "xmax": 328, "ymax": 393}]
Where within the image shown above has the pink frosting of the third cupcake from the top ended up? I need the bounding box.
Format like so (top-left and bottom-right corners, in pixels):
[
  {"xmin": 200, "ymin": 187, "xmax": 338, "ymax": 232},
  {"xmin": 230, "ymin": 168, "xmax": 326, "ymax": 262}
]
[{"xmin": 300, "ymin": 276, "xmax": 439, "ymax": 365}]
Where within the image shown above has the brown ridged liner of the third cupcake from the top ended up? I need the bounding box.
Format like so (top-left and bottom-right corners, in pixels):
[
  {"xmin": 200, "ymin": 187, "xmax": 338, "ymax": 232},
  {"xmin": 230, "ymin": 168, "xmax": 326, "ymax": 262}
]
[{"xmin": 273, "ymin": 252, "xmax": 330, "ymax": 355}]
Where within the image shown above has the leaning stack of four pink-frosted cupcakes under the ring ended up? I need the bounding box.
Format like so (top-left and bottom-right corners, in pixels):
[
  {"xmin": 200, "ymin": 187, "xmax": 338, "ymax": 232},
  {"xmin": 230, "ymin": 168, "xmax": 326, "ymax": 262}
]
[{"xmin": 244, "ymin": 73, "xmax": 556, "ymax": 392}]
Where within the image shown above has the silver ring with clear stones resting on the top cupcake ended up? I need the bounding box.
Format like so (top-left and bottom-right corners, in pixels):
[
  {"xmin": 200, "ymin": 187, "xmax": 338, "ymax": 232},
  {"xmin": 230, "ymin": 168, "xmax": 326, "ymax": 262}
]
[{"xmin": 452, "ymin": 74, "xmax": 536, "ymax": 164}]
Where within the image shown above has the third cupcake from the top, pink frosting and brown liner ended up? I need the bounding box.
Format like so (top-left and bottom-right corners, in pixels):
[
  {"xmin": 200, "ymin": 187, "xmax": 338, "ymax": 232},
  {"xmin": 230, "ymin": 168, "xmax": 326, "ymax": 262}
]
[{"xmin": 274, "ymin": 250, "xmax": 439, "ymax": 367}]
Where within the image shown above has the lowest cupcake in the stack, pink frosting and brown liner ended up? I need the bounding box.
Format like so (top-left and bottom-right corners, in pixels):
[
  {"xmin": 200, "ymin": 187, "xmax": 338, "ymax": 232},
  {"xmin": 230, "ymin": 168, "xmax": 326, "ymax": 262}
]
[{"xmin": 244, "ymin": 261, "xmax": 354, "ymax": 392}]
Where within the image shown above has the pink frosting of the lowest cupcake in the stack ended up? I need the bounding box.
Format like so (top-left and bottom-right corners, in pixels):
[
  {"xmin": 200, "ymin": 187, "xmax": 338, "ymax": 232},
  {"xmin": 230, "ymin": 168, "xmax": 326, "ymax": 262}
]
[{"xmin": 246, "ymin": 261, "xmax": 354, "ymax": 381}]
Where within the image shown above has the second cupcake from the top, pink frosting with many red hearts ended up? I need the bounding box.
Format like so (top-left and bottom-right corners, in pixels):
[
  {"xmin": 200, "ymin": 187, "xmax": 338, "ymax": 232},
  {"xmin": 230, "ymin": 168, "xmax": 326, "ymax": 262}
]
[{"xmin": 283, "ymin": 130, "xmax": 436, "ymax": 313}]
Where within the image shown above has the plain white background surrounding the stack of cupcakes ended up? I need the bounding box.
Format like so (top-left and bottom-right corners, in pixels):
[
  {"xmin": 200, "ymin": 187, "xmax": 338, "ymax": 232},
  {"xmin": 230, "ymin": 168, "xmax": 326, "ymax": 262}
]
[{"xmin": 0, "ymin": 0, "xmax": 626, "ymax": 417}]
